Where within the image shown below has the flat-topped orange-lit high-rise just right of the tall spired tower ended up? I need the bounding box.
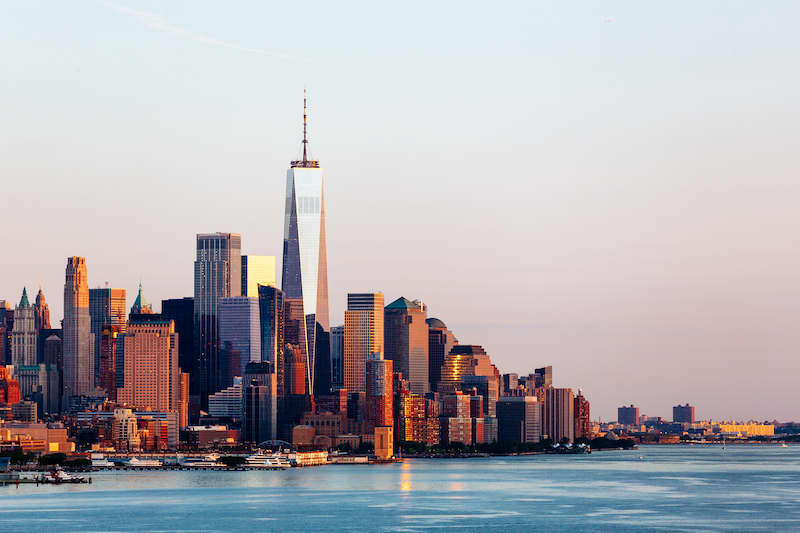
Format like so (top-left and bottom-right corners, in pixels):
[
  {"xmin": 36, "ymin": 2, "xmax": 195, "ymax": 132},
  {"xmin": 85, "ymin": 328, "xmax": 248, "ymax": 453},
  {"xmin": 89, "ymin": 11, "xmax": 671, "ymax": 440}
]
[{"xmin": 344, "ymin": 292, "xmax": 384, "ymax": 393}]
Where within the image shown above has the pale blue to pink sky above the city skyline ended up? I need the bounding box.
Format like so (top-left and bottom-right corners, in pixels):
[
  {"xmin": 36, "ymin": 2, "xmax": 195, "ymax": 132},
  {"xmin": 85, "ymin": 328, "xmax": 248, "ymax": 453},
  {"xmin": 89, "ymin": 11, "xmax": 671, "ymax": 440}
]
[{"xmin": 0, "ymin": 0, "xmax": 800, "ymax": 420}]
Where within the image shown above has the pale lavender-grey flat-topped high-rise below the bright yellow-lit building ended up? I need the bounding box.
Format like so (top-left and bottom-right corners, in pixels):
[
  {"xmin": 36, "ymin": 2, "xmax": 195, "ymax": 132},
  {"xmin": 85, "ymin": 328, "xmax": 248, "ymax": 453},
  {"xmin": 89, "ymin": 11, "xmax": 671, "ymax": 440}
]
[{"xmin": 219, "ymin": 296, "xmax": 261, "ymax": 387}]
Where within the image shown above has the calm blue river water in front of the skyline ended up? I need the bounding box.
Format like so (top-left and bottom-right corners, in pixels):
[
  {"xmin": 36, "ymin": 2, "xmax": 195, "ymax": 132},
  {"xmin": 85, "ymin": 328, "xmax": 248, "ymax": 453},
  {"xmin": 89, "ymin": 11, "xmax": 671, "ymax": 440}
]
[{"xmin": 0, "ymin": 446, "xmax": 800, "ymax": 532}]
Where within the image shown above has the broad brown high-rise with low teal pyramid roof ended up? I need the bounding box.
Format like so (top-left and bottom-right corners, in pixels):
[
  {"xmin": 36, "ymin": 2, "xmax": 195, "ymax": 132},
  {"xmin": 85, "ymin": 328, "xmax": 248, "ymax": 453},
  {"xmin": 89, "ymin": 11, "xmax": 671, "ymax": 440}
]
[{"xmin": 383, "ymin": 297, "xmax": 430, "ymax": 394}]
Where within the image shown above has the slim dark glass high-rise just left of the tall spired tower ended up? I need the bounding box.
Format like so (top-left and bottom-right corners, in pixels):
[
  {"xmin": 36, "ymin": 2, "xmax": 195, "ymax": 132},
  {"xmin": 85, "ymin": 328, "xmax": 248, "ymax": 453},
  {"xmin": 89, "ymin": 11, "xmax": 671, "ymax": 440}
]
[{"xmin": 258, "ymin": 285, "xmax": 286, "ymax": 398}]
